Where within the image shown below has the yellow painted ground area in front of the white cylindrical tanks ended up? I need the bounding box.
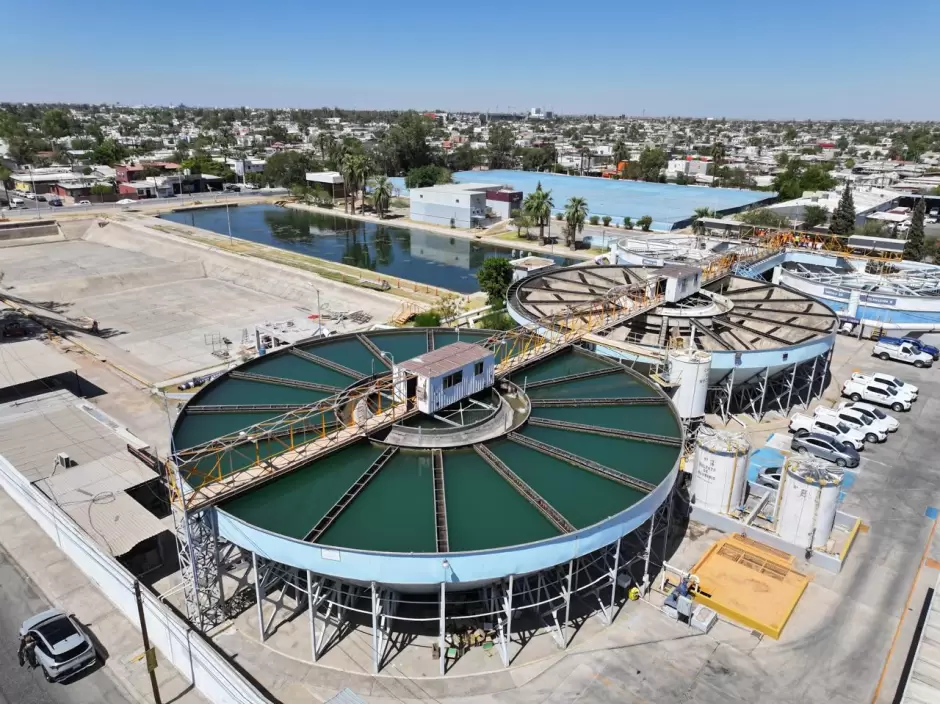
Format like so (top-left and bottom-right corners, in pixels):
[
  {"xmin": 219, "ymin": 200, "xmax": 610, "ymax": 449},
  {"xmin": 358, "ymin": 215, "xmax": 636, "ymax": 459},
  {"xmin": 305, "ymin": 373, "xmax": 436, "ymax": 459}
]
[{"xmin": 692, "ymin": 535, "xmax": 809, "ymax": 639}]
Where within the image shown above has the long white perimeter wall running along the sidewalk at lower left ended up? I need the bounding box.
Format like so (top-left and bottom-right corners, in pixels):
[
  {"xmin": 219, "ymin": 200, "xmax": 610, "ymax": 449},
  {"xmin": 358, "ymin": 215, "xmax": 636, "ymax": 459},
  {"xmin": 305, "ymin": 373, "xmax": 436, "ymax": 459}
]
[{"xmin": 0, "ymin": 456, "xmax": 271, "ymax": 704}]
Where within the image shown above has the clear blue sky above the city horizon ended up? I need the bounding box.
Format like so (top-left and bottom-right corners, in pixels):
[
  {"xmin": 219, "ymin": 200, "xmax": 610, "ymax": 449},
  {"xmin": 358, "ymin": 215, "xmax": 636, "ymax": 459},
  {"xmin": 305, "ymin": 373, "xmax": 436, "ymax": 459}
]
[{"xmin": 9, "ymin": 0, "xmax": 940, "ymax": 120}]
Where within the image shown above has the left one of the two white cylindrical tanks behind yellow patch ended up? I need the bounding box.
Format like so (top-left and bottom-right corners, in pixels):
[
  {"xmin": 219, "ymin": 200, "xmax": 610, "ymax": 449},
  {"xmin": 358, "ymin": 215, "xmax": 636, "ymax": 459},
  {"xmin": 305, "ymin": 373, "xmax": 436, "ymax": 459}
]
[{"xmin": 691, "ymin": 426, "xmax": 750, "ymax": 513}]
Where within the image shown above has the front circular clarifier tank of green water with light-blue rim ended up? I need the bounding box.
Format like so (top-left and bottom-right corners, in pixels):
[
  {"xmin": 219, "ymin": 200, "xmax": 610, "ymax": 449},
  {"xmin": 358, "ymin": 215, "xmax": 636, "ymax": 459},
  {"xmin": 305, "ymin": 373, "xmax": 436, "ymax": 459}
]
[{"xmin": 173, "ymin": 328, "xmax": 682, "ymax": 591}]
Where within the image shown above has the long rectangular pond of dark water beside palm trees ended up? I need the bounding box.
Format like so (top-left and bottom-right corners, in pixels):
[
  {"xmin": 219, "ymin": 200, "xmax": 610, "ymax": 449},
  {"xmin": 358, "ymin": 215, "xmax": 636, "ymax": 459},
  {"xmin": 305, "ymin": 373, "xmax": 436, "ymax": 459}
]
[{"xmin": 160, "ymin": 201, "xmax": 580, "ymax": 293}]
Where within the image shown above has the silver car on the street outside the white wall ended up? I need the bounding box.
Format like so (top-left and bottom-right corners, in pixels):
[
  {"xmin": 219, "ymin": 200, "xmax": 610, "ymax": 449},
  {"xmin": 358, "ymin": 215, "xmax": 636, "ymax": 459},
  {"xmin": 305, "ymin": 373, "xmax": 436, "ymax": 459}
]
[{"xmin": 20, "ymin": 609, "xmax": 98, "ymax": 682}]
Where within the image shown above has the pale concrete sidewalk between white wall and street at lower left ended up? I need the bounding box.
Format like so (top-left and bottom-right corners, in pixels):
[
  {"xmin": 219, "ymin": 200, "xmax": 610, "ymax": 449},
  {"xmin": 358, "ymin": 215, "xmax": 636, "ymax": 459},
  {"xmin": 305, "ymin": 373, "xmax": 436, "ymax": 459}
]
[{"xmin": 0, "ymin": 484, "xmax": 206, "ymax": 704}]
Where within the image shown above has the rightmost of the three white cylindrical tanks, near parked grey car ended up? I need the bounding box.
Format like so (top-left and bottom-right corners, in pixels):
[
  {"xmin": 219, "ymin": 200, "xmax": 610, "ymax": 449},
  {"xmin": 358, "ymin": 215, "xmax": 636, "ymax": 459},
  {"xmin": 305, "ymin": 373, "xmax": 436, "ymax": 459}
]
[{"xmin": 777, "ymin": 458, "xmax": 844, "ymax": 548}]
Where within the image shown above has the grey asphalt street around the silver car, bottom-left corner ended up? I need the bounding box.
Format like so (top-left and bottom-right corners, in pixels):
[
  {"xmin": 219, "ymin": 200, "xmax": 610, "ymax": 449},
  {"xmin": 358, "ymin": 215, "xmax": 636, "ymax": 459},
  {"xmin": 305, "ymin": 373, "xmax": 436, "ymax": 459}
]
[{"xmin": 0, "ymin": 547, "xmax": 134, "ymax": 704}]
